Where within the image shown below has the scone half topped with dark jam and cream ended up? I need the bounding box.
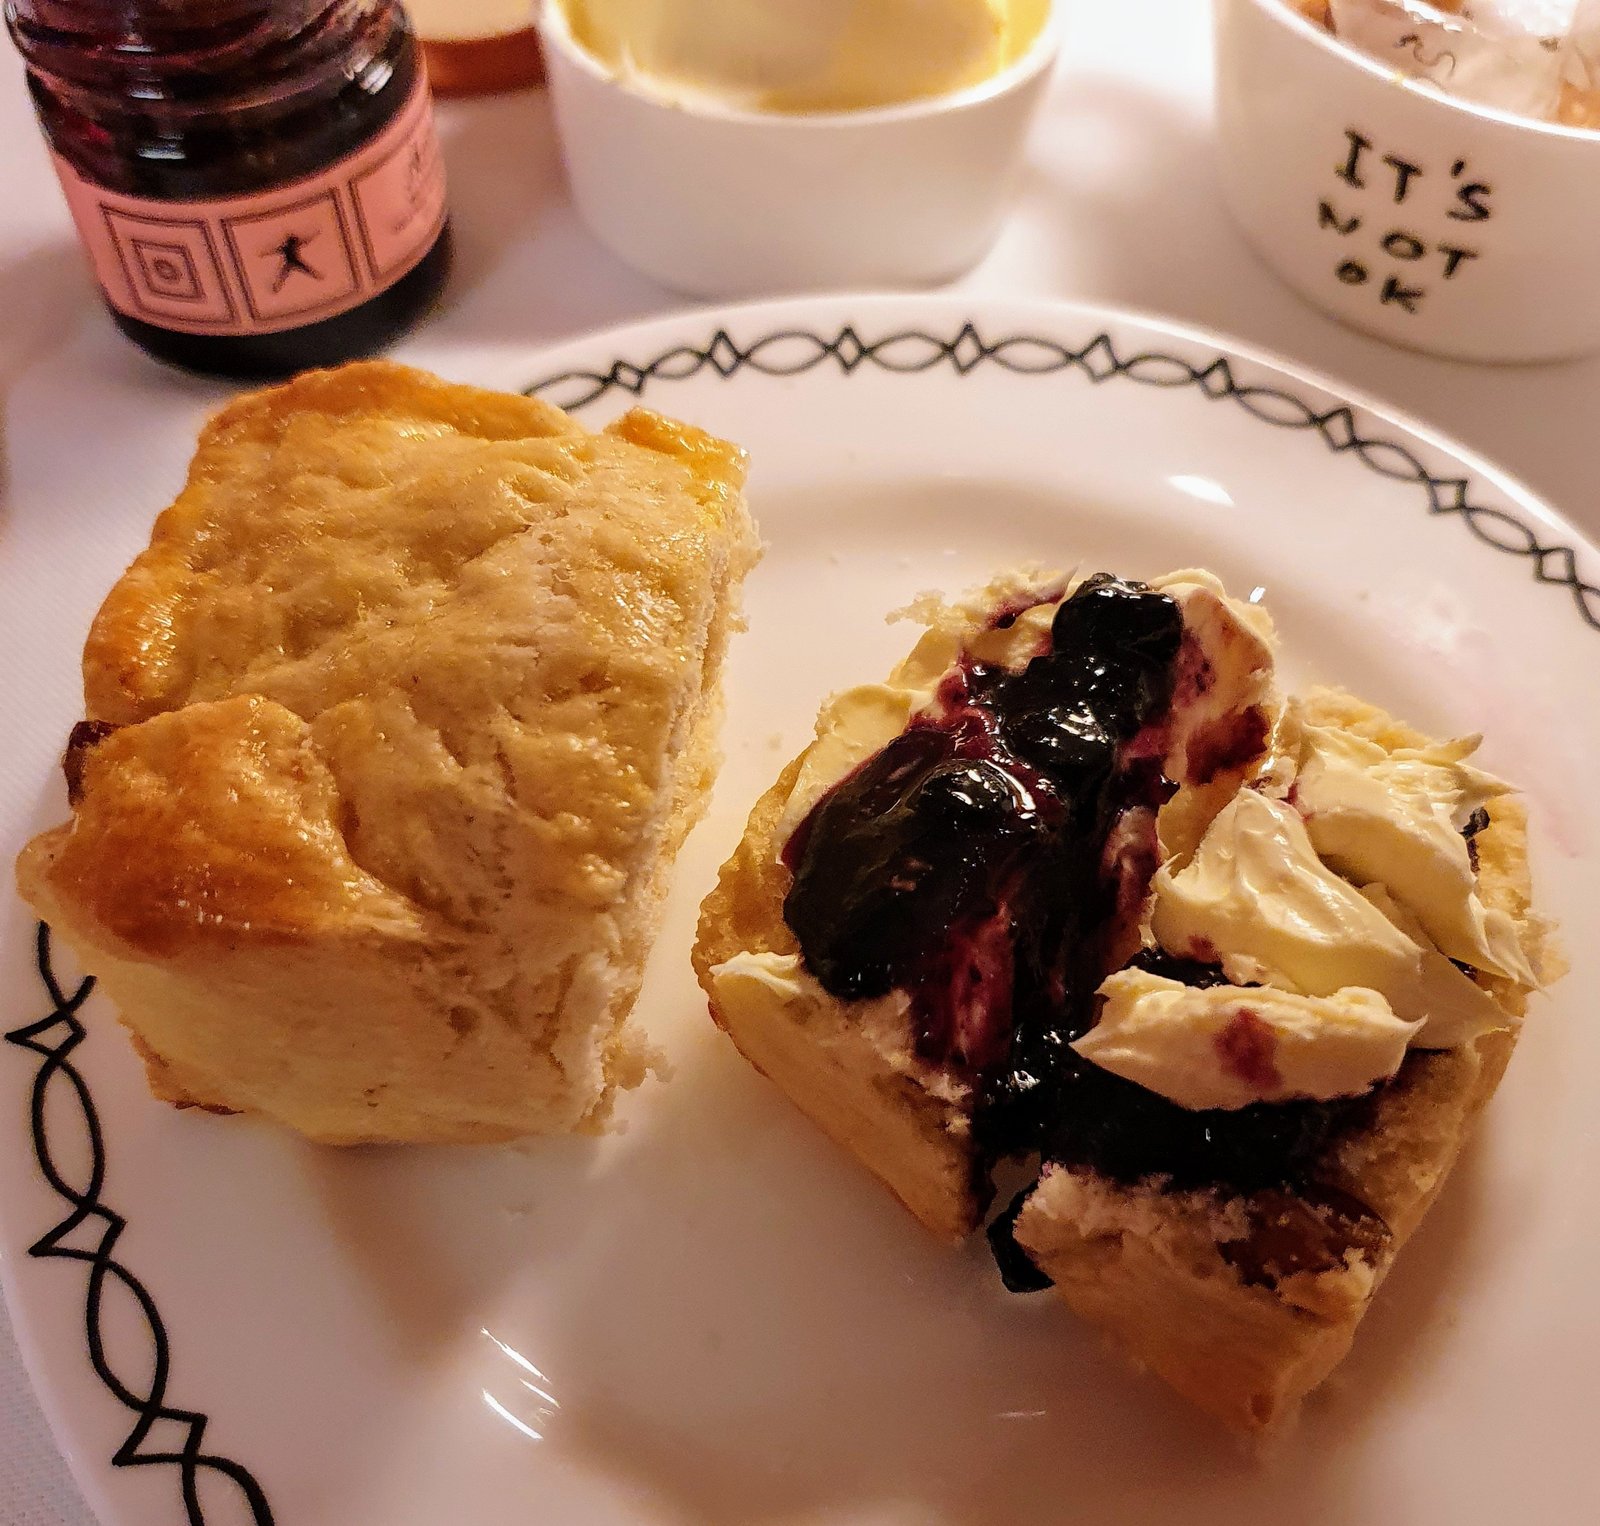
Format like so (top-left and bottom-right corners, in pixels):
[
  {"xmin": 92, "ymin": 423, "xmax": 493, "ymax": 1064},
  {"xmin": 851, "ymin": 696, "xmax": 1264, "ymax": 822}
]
[{"xmin": 696, "ymin": 573, "xmax": 1550, "ymax": 1430}]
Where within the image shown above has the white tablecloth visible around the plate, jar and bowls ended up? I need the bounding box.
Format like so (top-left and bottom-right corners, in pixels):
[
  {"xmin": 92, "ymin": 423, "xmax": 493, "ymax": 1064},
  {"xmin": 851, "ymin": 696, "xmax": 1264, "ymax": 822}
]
[{"xmin": 0, "ymin": 0, "xmax": 1600, "ymax": 1526}]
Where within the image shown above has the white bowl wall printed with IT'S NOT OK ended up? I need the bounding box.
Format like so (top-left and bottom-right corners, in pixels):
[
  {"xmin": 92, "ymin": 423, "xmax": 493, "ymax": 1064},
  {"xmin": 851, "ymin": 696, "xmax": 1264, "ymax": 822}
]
[{"xmin": 1216, "ymin": 0, "xmax": 1600, "ymax": 360}]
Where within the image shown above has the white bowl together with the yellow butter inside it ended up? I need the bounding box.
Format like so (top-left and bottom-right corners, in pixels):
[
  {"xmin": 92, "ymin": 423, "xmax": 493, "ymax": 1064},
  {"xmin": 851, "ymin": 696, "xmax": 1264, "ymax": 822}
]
[{"xmin": 541, "ymin": 0, "xmax": 1058, "ymax": 298}]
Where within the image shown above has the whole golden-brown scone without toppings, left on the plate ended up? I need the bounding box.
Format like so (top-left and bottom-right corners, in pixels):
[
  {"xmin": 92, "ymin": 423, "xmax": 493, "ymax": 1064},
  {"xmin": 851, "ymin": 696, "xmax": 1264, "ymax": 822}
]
[{"xmin": 18, "ymin": 363, "xmax": 757, "ymax": 1144}]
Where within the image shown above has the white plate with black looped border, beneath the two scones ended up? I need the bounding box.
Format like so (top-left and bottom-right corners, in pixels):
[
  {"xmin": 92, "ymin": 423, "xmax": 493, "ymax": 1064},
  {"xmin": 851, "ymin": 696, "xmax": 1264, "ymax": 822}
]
[{"xmin": 0, "ymin": 298, "xmax": 1600, "ymax": 1526}]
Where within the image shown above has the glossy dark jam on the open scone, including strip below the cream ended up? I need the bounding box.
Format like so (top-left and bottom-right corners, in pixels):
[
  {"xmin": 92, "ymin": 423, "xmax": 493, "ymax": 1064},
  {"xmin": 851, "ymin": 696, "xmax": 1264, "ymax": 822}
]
[{"xmin": 784, "ymin": 574, "xmax": 1371, "ymax": 1238}]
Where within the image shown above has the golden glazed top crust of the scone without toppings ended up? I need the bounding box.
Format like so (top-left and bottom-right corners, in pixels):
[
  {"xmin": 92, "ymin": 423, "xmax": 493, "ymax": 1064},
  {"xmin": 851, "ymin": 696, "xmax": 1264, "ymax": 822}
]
[{"xmin": 54, "ymin": 365, "xmax": 742, "ymax": 953}]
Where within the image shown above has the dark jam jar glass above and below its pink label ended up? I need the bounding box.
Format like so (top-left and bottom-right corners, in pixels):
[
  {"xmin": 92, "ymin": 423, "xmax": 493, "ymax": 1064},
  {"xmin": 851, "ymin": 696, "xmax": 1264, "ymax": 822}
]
[{"xmin": 6, "ymin": 0, "xmax": 450, "ymax": 378}]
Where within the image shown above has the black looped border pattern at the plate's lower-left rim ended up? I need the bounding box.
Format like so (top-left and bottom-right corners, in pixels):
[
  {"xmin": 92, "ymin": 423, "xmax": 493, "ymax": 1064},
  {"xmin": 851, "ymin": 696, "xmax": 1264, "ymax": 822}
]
[{"xmin": 5, "ymin": 923, "xmax": 272, "ymax": 1526}]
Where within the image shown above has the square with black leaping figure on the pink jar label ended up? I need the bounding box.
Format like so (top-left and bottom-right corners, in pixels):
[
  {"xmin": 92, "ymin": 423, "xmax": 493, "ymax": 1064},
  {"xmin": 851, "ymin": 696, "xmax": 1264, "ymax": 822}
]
[{"xmin": 222, "ymin": 189, "xmax": 360, "ymax": 318}]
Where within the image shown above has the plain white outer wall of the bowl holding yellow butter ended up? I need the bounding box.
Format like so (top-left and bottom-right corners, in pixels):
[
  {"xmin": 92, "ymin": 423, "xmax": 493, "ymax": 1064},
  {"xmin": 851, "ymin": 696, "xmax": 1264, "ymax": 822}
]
[{"xmin": 541, "ymin": 3, "xmax": 1059, "ymax": 298}]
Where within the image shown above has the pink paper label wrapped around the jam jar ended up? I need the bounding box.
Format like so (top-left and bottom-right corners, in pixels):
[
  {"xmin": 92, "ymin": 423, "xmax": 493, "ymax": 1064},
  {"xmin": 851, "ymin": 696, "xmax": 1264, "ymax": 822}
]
[{"xmin": 54, "ymin": 78, "xmax": 445, "ymax": 336}]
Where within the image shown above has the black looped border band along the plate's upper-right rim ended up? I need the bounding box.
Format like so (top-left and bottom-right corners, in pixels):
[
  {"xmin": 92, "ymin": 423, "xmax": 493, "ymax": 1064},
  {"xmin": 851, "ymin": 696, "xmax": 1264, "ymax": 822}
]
[{"xmin": 523, "ymin": 322, "xmax": 1600, "ymax": 630}]
